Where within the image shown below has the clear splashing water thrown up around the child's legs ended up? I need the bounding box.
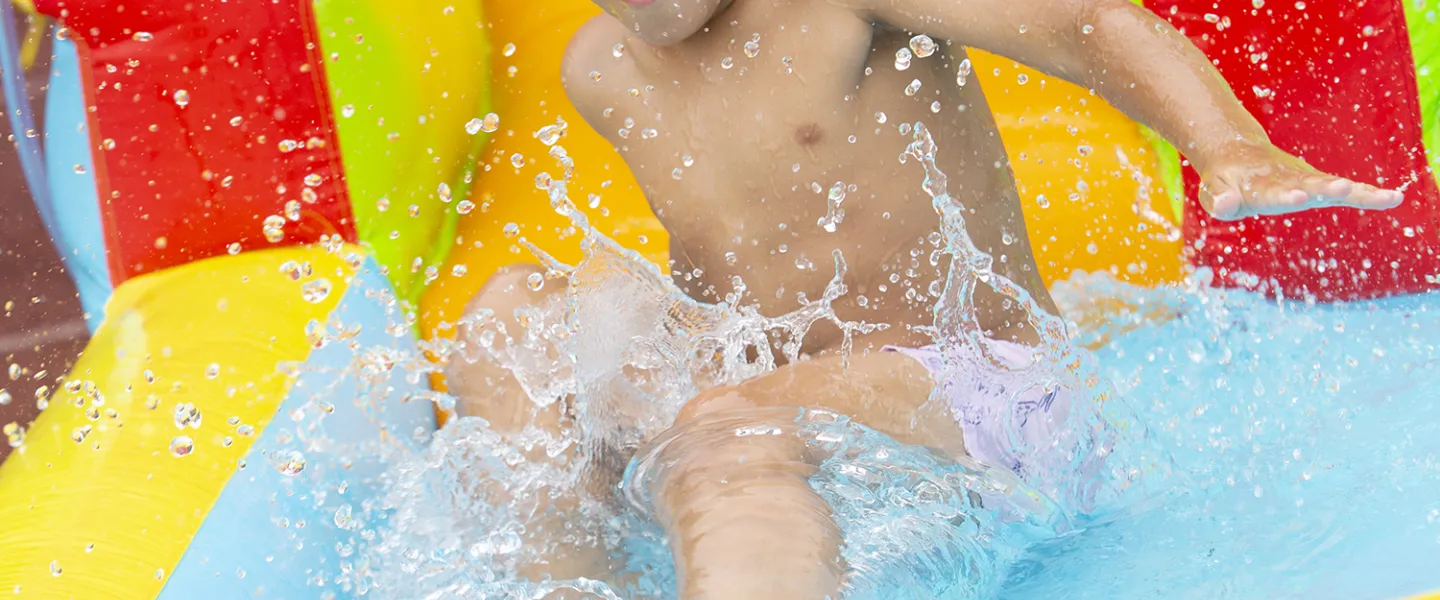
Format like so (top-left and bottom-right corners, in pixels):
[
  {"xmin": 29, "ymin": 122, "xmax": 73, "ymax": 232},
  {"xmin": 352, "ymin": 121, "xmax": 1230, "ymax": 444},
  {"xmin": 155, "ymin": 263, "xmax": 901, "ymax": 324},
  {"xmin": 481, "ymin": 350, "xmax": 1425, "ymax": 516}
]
[{"xmin": 346, "ymin": 121, "xmax": 1163, "ymax": 599}]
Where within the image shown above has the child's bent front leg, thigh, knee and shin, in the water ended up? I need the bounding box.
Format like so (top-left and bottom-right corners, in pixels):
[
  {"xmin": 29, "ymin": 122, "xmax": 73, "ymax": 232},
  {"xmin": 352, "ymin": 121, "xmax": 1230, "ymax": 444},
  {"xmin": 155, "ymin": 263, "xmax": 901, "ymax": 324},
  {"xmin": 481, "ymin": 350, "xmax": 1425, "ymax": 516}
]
[{"xmin": 649, "ymin": 354, "xmax": 963, "ymax": 599}]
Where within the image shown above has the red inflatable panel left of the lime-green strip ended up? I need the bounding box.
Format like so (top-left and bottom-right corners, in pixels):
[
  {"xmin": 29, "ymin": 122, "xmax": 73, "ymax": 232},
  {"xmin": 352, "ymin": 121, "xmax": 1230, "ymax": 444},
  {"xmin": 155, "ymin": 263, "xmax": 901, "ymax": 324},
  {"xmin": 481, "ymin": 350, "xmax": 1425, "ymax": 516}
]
[{"xmin": 36, "ymin": 0, "xmax": 356, "ymax": 285}]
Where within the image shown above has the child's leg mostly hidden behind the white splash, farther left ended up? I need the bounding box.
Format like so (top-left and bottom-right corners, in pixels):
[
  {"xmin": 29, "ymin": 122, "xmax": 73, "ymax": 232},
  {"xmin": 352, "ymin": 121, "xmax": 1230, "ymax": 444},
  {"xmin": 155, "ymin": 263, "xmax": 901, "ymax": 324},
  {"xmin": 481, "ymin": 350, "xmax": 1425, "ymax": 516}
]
[{"xmin": 445, "ymin": 265, "xmax": 609, "ymax": 581}]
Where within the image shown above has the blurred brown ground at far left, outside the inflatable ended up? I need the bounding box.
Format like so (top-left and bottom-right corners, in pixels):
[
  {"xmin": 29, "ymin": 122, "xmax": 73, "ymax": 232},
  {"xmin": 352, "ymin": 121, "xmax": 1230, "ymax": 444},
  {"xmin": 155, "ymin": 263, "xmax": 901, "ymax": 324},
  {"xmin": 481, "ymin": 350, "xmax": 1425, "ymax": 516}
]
[{"xmin": 0, "ymin": 29, "xmax": 89, "ymax": 460}]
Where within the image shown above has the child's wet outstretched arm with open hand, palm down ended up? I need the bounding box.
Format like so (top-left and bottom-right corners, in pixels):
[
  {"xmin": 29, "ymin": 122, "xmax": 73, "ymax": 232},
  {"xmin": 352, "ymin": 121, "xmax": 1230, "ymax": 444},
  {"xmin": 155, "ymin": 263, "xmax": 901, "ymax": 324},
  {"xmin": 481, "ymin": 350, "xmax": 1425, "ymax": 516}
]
[{"xmin": 831, "ymin": 0, "xmax": 1403, "ymax": 219}]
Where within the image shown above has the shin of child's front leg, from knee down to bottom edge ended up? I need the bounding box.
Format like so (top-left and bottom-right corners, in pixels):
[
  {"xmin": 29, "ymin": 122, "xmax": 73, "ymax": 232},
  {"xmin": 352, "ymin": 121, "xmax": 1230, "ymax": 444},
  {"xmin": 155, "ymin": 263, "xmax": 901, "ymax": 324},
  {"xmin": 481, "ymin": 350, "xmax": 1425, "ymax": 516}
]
[{"xmin": 652, "ymin": 409, "xmax": 844, "ymax": 600}]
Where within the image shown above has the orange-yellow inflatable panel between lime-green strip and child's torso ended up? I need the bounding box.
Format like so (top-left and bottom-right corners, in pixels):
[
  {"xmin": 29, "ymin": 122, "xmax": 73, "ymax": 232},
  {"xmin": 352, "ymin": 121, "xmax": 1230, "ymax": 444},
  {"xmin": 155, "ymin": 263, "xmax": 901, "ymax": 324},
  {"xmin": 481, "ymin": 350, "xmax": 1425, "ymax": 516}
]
[{"xmin": 420, "ymin": 0, "xmax": 670, "ymax": 337}]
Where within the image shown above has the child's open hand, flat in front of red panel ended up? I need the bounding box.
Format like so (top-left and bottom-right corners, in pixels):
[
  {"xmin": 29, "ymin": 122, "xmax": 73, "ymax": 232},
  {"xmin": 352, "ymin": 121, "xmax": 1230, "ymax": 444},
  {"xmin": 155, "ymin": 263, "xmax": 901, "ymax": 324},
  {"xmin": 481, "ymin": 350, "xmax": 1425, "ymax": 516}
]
[{"xmin": 1200, "ymin": 142, "xmax": 1404, "ymax": 220}]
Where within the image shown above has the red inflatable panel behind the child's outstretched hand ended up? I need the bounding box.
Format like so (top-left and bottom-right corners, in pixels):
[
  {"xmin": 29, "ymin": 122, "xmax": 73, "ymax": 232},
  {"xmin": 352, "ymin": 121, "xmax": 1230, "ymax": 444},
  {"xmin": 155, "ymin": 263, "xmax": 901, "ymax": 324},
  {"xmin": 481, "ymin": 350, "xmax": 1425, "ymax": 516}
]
[{"xmin": 1145, "ymin": 0, "xmax": 1440, "ymax": 301}]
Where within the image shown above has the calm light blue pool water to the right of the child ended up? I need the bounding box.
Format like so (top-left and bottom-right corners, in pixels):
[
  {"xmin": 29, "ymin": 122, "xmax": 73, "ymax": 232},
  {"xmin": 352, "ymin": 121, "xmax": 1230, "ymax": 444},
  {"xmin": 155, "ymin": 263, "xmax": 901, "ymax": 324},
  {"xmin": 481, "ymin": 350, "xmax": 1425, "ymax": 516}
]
[{"xmin": 999, "ymin": 283, "xmax": 1440, "ymax": 600}]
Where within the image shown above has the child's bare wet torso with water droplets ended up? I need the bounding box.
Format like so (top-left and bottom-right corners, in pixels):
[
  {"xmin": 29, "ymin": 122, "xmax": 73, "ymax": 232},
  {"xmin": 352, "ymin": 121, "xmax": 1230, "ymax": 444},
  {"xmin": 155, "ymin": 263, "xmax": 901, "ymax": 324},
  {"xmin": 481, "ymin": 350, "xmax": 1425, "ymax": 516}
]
[{"xmin": 566, "ymin": 0, "xmax": 1044, "ymax": 351}]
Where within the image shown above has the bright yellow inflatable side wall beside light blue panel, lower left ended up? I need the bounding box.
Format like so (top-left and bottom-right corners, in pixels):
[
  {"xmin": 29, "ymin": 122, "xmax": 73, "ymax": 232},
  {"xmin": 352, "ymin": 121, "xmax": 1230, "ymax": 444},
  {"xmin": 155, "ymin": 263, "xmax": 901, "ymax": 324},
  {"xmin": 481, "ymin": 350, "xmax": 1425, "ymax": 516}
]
[{"xmin": 0, "ymin": 247, "xmax": 354, "ymax": 597}]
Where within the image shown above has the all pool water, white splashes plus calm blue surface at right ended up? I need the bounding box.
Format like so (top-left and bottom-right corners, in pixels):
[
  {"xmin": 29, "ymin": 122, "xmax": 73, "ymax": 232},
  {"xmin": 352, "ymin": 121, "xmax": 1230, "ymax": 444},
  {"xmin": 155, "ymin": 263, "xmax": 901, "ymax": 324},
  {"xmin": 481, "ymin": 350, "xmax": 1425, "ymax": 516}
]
[{"xmin": 341, "ymin": 119, "xmax": 1440, "ymax": 599}]
